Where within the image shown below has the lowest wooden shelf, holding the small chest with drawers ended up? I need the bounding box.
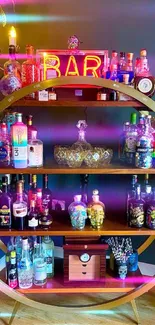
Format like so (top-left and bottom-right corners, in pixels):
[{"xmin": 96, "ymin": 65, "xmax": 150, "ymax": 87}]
[{"xmin": 0, "ymin": 263, "xmax": 147, "ymax": 294}]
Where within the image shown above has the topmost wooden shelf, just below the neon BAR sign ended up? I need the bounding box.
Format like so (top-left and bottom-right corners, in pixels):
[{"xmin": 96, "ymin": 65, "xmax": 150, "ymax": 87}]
[{"xmin": 12, "ymin": 99, "xmax": 145, "ymax": 110}]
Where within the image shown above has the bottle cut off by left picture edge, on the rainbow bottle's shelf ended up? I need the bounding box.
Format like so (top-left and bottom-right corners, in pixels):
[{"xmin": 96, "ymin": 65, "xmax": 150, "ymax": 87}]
[{"xmin": 0, "ymin": 123, "xmax": 11, "ymax": 167}]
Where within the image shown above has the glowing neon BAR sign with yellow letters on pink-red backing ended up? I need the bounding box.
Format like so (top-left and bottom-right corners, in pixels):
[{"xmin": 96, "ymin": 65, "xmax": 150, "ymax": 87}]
[{"xmin": 36, "ymin": 50, "xmax": 108, "ymax": 80}]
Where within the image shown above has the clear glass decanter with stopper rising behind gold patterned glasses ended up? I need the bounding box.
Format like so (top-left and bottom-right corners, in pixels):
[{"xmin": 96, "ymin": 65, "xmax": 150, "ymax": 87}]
[{"xmin": 71, "ymin": 120, "xmax": 92, "ymax": 150}]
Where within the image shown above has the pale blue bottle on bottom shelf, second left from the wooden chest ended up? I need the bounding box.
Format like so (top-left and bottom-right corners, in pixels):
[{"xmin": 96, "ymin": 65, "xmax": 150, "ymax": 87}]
[{"xmin": 33, "ymin": 244, "xmax": 47, "ymax": 286}]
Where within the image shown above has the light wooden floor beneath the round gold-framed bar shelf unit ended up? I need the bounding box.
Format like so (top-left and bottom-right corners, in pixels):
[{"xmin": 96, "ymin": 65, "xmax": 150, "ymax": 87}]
[{"xmin": 0, "ymin": 291, "xmax": 155, "ymax": 325}]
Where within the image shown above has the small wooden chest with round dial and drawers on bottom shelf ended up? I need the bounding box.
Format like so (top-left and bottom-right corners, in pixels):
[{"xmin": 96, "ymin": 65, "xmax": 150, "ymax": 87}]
[{"xmin": 63, "ymin": 243, "xmax": 108, "ymax": 283}]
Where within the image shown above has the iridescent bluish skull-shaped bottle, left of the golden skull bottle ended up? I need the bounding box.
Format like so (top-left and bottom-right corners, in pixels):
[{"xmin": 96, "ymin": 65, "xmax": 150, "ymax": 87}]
[{"xmin": 68, "ymin": 195, "xmax": 87, "ymax": 229}]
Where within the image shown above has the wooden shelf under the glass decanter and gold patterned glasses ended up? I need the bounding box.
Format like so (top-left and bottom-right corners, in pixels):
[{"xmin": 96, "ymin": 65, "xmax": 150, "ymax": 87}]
[{"xmin": 0, "ymin": 162, "xmax": 155, "ymax": 175}]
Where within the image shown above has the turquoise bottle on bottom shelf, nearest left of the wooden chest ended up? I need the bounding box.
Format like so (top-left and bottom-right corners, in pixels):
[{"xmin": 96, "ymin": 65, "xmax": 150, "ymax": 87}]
[{"xmin": 42, "ymin": 236, "xmax": 54, "ymax": 278}]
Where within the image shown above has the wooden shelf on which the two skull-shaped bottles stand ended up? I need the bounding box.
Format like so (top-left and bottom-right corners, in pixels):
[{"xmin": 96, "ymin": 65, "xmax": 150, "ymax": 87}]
[{"xmin": 0, "ymin": 218, "xmax": 155, "ymax": 237}]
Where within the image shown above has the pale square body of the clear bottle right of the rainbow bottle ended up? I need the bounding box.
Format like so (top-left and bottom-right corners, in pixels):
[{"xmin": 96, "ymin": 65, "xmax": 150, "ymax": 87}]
[{"xmin": 28, "ymin": 144, "xmax": 43, "ymax": 167}]
